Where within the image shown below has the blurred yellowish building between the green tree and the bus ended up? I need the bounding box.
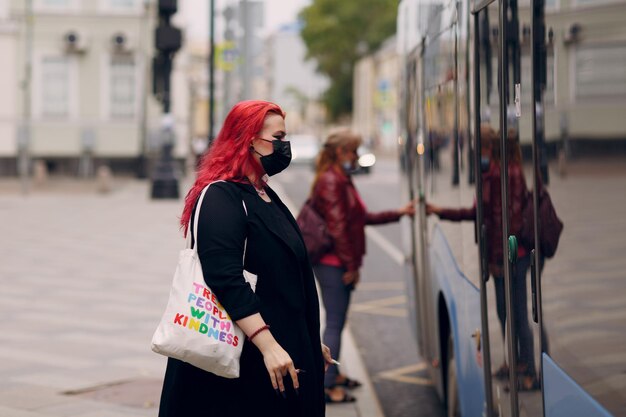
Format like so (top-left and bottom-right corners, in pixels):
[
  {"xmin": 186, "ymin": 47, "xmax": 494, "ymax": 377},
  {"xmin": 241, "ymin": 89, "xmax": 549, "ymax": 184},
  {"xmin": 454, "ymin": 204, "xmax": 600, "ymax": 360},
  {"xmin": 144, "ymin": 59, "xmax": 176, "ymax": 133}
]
[{"xmin": 352, "ymin": 36, "xmax": 400, "ymax": 152}]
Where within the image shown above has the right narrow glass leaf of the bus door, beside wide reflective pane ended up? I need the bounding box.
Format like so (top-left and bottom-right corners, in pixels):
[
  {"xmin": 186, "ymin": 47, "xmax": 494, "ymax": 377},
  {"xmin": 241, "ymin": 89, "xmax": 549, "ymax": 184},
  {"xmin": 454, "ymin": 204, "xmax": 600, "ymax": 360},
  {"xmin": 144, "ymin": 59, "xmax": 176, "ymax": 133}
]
[{"xmin": 494, "ymin": 0, "xmax": 547, "ymax": 416}]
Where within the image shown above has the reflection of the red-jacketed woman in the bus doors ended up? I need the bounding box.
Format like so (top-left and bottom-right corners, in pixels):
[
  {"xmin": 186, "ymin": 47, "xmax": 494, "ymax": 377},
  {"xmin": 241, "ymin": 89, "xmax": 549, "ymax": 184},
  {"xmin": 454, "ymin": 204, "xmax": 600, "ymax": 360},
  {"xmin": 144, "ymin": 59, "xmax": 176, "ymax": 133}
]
[{"xmin": 426, "ymin": 124, "xmax": 538, "ymax": 389}]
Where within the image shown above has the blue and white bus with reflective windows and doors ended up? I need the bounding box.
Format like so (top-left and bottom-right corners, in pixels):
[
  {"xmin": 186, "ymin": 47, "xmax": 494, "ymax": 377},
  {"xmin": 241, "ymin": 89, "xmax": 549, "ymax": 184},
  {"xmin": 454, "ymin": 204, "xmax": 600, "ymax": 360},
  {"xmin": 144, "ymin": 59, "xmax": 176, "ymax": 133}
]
[{"xmin": 397, "ymin": 0, "xmax": 626, "ymax": 417}]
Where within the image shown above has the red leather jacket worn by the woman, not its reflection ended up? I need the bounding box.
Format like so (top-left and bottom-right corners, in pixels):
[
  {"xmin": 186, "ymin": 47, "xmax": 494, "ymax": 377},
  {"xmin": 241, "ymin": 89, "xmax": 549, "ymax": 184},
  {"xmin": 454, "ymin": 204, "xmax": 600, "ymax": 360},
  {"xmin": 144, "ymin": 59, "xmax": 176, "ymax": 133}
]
[{"xmin": 312, "ymin": 167, "xmax": 401, "ymax": 271}]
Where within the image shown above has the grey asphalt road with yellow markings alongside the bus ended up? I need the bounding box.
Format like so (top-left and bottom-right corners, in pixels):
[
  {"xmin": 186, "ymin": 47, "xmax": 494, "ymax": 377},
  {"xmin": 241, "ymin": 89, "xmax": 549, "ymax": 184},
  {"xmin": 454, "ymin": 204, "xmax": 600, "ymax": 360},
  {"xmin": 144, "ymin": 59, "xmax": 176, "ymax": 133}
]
[{"xmin": 270, "ymin": 160, "xmax": 444, "ymax": 417}]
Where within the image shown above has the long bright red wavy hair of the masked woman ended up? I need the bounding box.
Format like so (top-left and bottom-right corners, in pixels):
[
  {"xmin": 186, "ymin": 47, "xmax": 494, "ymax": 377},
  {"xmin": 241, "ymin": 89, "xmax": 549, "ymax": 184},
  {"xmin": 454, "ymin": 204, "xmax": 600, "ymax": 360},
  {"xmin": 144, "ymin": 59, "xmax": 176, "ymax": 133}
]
[{"xmin": 180, "ymin": 100, "xmax": 285, "ymax": 234}]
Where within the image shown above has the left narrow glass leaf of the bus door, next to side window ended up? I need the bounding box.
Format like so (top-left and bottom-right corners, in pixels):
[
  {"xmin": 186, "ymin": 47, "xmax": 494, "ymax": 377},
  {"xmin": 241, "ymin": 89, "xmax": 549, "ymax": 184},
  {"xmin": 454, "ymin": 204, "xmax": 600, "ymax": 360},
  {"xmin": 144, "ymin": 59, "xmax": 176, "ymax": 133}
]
[{"xmin": 472, "ymin": 0, "xmax": 504, "ymax": 416}]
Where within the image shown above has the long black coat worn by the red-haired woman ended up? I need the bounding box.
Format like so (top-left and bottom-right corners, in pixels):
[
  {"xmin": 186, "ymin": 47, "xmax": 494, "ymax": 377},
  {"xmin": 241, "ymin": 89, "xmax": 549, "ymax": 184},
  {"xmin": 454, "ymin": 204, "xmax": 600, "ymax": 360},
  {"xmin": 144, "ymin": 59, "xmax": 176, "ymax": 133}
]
[{"xmin": 159, "ymin": 182, "xmax": 325, "ymax": 417}]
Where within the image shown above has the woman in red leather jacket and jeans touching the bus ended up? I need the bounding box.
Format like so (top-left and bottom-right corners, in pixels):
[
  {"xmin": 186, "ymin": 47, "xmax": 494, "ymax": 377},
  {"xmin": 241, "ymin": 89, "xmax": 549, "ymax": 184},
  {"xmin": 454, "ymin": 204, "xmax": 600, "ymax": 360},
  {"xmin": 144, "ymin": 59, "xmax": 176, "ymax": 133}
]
[{"xmin": 311, "ymin": 131, "xmax": 415, "ymax": 403}]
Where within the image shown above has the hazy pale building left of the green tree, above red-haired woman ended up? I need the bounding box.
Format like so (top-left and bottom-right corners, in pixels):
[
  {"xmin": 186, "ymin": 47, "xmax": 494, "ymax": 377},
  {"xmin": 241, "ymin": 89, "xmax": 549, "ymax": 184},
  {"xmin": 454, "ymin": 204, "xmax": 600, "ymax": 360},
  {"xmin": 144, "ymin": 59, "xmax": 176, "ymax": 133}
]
[{"xmin": 253, "ymin": 22, "xmax": 328, "ymax": 137}]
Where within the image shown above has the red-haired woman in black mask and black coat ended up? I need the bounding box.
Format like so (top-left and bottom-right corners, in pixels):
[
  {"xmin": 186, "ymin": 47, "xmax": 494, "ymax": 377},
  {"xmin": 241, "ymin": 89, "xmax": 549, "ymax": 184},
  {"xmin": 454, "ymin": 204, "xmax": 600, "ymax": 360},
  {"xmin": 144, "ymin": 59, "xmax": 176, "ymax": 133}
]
[{"xmin": 159, "ymin": 101, "xmax": 332, "ymax": 417}]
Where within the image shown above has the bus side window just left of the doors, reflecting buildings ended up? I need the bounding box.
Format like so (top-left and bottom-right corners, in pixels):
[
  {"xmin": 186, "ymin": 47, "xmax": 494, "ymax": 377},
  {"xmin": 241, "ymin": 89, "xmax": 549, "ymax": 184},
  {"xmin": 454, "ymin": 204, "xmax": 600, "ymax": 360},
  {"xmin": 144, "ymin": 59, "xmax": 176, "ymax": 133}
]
[{"xmin": 422, "ymin": 2, "xmax": 486, "ymax": 288}]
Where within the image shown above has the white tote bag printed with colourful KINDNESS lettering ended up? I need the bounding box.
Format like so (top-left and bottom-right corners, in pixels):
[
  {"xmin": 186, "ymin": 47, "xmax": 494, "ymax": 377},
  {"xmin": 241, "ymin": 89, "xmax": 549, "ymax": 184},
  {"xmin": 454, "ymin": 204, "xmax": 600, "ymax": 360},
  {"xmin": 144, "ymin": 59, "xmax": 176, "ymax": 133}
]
[{"xmin": 152, "ymin": 181, "xmax": 257, "ymax": 378}]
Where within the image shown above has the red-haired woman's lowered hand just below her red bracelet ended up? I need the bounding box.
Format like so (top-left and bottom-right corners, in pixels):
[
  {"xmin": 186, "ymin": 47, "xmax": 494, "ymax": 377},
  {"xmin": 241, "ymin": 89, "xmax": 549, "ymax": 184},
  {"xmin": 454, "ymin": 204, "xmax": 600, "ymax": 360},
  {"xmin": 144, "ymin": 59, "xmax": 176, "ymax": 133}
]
[{"xmin": 254, "ymin": 331, "xmax": 300, "ymax": 397}]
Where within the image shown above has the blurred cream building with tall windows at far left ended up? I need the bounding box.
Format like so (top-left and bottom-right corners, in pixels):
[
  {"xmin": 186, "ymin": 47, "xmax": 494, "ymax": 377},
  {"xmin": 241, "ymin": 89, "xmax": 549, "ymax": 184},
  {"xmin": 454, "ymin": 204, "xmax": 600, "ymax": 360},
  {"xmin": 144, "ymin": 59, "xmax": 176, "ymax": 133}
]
[{"xmin": 0, "ymin": 0, "xmax": 190, "ymax": 175}]
